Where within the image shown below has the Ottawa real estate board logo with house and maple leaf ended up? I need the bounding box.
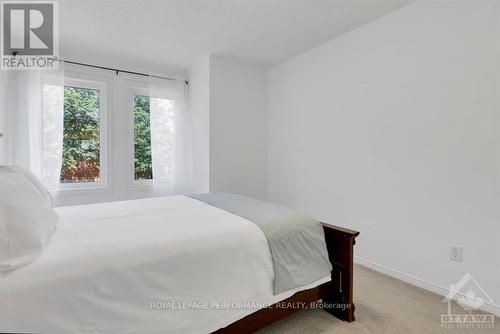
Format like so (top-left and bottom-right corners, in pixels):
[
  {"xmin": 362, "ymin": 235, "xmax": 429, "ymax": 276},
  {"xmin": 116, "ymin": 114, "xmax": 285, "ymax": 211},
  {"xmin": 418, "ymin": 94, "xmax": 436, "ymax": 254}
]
[{"xmin": 441, "ymin": 273, "xmax": 495, "ymax": 329}]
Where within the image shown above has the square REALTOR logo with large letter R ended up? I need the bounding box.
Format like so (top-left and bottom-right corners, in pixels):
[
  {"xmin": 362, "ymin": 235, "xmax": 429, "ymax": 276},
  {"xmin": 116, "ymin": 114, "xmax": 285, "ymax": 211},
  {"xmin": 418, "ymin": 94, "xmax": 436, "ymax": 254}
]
[{"xmin": 0, "ymin": 1, "xmax": 59, "ymax": 70}]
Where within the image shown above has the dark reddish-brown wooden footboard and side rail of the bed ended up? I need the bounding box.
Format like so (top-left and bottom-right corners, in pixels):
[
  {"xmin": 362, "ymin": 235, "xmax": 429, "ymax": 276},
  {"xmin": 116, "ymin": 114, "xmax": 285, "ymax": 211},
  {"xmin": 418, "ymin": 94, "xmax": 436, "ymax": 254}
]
[{"xmin": 213, "ymin": 223, "xmax": 359, "ymax": 334}]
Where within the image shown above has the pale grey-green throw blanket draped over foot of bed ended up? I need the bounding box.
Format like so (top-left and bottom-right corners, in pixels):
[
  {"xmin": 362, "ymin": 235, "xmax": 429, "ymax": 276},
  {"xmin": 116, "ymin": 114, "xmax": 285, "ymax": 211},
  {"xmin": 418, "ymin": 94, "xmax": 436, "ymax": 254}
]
[{"xmin": 188, "ymin": 193, "xmax": 332, "ymax": 294}]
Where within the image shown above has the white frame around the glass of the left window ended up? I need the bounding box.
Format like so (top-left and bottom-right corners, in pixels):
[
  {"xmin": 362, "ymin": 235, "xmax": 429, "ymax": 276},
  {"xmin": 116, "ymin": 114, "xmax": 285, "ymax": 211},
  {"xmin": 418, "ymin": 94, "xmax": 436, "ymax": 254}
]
[{"xmin": 42, "ymin": 71, "xmax": 108, "ymax": 193}]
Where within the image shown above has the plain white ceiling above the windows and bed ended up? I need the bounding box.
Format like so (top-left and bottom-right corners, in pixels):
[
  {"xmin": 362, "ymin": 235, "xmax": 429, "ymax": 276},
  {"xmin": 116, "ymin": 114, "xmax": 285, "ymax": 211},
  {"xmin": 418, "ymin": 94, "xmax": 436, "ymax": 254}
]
[{"xmin": 60, "ymin": 0, "xmax": 412, "ymax": 68}]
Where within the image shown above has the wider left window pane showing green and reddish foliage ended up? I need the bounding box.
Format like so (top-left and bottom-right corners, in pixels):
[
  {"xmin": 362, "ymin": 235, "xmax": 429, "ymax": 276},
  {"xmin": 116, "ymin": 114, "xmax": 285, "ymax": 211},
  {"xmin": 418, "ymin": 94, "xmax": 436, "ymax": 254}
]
[{"xmin": 61, "ymin": 86, "xmax": 100, "ymax": 183}]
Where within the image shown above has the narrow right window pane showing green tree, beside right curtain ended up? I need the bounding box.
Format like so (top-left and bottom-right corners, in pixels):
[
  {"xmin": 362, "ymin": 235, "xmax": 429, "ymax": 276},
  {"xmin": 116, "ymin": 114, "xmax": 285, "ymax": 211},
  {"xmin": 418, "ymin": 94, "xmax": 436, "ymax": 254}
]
[{"xmin": 134, "ymin": 95, "xmax": 153, "ymax": 180}]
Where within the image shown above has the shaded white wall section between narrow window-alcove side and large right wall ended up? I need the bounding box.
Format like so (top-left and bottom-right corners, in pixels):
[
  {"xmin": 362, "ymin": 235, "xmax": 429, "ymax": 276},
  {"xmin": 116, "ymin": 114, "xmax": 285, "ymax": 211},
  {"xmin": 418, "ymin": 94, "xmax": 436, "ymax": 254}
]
[{"xmin": 209, "ymin": 56, "xmax": 267, "ymax": 199}]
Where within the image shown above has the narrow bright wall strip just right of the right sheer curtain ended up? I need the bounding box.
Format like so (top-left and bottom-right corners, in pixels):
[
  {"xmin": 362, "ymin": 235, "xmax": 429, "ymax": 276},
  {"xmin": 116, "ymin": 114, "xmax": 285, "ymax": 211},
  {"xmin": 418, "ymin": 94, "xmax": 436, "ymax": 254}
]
[{"xmin": 189, "ymin": 55, "xmax": 210, "ymax": 193}]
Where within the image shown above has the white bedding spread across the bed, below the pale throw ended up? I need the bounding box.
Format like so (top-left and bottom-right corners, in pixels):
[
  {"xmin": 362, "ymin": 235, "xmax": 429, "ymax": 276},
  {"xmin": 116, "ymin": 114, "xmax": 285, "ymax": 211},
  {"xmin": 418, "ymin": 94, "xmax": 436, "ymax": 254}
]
[{"xmin": 0, "ymin": 196, "xmax": 330, "ymax": 334}]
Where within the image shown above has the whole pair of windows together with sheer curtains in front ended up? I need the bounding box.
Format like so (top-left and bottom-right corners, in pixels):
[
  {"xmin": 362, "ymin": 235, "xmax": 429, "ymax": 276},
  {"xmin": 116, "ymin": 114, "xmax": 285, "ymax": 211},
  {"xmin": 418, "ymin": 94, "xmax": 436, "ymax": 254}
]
[{"xmin": 34, "ymin": 66, "xmax": 188, "ymax": 202}]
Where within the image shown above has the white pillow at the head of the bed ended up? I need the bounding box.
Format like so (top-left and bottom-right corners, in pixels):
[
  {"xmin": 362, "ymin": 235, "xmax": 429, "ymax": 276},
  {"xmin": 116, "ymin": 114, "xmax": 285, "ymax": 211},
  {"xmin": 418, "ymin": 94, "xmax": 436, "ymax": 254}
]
[{"xmin": 0, "ymin": 167, "xmax": 58, "ymax": 271}]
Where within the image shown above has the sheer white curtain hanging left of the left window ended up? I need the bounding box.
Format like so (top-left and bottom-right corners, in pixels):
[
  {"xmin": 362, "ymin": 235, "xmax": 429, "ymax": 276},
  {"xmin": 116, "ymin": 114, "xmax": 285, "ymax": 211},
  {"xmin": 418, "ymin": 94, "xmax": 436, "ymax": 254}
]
[{"xmin": 2, "ymin": 66, "xmax": 64, "ymax": 190}]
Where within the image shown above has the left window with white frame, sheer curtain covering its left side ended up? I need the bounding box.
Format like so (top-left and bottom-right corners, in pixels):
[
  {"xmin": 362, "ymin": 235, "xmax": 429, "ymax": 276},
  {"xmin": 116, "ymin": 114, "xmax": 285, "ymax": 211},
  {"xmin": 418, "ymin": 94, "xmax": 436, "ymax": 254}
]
[{"xmin": 42, "ymin": 72, "xmax": 107, "ymax": 190}]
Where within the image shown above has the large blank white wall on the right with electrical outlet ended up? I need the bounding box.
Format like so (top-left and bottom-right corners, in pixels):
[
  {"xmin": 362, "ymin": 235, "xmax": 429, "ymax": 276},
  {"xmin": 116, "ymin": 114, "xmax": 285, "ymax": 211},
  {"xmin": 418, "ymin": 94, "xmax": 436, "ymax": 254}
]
[{"xmin": 268, "ymin": 1, "xmax": 500, "ymax": 313}]
